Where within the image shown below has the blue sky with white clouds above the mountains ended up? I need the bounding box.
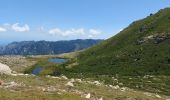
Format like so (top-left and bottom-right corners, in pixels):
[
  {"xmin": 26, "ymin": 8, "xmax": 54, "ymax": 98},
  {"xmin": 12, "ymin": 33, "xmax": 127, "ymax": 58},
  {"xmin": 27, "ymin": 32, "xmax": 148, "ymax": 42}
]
[{"xmin": 0, "ymin": 0, "xmax": 170, "ymax": 44}]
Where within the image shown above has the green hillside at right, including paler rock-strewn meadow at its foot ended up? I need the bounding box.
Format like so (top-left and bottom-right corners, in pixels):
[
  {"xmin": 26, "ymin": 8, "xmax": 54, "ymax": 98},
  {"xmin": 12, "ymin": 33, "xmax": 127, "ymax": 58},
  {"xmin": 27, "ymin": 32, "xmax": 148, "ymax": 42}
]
[{"xmin": 55, "ymin": 8, "xmax": 170, "ymax": 96}]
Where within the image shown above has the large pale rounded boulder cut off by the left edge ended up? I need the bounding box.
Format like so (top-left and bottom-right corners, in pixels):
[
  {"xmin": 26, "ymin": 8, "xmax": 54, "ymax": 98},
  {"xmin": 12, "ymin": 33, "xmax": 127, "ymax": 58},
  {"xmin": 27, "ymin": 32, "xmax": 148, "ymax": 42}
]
[{"xmin": 0, "ymin": 63, "xmax": 12, "ymax": 75}]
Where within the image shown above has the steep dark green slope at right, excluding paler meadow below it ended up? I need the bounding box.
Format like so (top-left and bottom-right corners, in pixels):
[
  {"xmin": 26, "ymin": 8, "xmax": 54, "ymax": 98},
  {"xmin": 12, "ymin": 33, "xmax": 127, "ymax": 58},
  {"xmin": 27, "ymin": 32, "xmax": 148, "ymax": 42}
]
[{"xmin": 66, "ymin": 8, "xmax": 170, "ymax": 75}]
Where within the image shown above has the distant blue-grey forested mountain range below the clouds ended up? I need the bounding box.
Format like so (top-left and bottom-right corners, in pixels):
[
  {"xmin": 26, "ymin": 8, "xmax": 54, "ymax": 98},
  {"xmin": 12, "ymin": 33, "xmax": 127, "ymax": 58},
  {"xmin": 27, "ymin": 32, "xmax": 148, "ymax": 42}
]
[{"xmin": 0, "ymin": 39, "xmax": 103, "ymax": 55}]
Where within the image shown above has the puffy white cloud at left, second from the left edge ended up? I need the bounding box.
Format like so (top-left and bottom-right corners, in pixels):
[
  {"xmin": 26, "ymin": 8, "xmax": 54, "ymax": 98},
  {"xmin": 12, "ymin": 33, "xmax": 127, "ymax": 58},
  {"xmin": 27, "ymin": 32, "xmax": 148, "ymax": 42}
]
[{"xmin": 11, "ymin": 23, "xmax": 30, "ymax": 32}]
